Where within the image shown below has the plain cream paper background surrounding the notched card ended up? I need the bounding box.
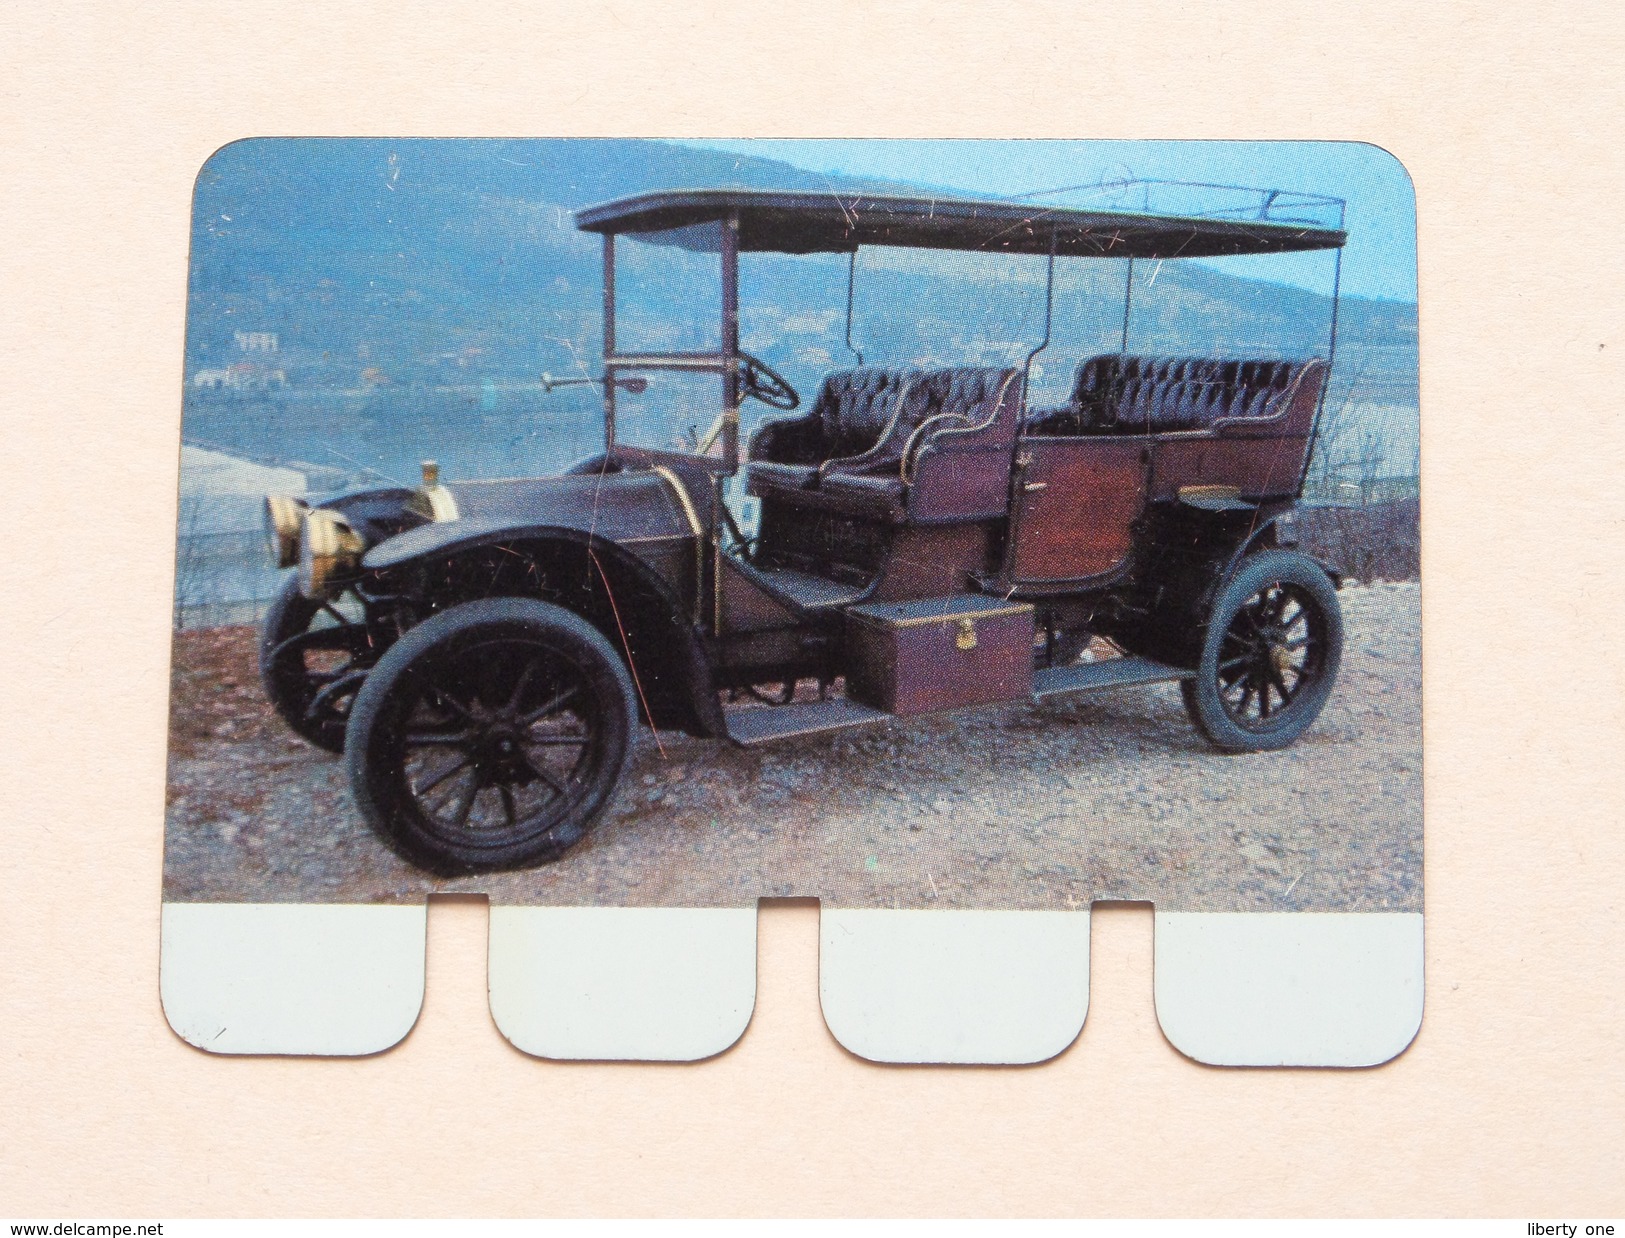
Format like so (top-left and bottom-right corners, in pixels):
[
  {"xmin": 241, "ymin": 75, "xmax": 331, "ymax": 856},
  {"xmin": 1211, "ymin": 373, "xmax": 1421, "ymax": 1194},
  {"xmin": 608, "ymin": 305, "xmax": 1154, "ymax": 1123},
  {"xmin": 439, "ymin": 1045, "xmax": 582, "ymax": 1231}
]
[{"xmin": 0, "ymin": 0, "xmax": 1625, "ymax": 1219}]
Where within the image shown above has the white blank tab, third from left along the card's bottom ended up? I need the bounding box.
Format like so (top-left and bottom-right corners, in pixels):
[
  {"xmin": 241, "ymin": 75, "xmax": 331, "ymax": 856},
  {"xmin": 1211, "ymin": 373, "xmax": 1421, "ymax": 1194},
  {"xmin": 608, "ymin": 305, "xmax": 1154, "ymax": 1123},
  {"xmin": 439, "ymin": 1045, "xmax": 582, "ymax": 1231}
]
[{"xmin": 819, "ymin": 907, "xmax": 1089, "ymax": 1066}]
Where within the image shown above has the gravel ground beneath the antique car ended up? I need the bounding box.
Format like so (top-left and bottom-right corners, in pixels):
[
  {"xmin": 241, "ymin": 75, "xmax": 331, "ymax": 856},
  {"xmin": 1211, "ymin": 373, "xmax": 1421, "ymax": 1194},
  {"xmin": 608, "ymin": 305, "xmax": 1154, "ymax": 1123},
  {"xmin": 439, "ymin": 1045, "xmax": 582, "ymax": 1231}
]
[{"xmin": 164, "ymin": 583, "xmax": 1422, "ymax": 911}]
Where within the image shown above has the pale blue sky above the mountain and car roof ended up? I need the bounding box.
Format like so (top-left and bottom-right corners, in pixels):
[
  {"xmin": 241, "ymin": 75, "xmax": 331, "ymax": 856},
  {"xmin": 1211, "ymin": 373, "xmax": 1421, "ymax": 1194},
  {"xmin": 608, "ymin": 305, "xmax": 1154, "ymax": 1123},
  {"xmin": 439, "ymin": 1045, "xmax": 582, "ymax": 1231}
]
[{"xmin": 669, "ymin": 138, "xmax": 1417, "ymax": 302}]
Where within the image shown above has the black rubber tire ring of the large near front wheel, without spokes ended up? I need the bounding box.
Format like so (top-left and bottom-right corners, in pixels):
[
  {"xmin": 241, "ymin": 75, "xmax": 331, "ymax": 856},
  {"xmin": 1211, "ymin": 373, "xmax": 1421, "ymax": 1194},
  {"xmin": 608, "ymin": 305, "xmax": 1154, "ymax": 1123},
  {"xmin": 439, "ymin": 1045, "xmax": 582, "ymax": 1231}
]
[{"xmin": 345, "ymin": 598, "xmax": 637, "ymax": 876}]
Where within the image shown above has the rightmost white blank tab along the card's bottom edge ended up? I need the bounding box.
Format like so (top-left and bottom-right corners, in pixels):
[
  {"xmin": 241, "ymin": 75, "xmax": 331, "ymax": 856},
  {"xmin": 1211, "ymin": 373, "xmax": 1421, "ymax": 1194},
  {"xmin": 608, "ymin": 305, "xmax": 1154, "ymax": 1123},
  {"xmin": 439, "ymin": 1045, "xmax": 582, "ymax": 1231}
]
[{"xmin": 1155, "ymin": 911, "xmax": 1422, "ymax": 1066}]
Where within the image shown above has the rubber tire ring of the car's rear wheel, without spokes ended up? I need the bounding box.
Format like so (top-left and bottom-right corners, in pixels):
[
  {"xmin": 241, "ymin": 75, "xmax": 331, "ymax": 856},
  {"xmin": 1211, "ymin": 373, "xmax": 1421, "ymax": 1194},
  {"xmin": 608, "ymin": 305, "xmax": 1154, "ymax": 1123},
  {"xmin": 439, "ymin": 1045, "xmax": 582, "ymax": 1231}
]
[{"xmin": 1180, "ymin": 549, "xmax": 1342, "ymax": 752}]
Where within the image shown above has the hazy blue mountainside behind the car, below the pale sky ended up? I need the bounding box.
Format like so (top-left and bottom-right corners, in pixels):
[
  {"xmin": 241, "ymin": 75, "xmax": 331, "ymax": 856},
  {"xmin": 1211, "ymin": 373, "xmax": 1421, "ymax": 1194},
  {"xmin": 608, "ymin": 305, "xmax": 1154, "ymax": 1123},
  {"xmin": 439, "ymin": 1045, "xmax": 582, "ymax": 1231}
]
[{"xmin": 187, "ymin": 138, "xmax": 1417, "ymax": 406}]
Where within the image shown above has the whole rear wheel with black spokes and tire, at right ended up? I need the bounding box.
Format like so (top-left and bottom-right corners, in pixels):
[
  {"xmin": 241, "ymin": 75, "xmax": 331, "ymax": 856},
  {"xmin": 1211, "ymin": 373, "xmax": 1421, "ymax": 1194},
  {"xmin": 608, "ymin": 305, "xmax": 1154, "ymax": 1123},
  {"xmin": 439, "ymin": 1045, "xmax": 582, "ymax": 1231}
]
[{"xmin": 1181, "ymin": 551, "xmax": 1342, "ymax": 752}]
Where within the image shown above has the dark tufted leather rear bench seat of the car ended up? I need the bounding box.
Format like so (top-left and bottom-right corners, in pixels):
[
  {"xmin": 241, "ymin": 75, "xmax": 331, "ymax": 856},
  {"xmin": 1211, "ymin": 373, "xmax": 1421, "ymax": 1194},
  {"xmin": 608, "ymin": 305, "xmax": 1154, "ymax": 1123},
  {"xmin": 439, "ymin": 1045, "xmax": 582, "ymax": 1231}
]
[{"xmin": 1027, "ymin": 353, "xmax": 1321, "ymax": 435}]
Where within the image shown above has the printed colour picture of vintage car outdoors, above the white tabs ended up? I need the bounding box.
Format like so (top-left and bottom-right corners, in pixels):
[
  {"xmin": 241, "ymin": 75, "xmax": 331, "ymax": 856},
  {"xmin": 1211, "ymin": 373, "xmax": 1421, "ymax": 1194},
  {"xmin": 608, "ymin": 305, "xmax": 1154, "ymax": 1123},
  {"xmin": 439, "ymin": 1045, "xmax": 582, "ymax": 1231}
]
[{"xmin": 166, "ymin": 141, "xmax": 1420, "ymax": 910}]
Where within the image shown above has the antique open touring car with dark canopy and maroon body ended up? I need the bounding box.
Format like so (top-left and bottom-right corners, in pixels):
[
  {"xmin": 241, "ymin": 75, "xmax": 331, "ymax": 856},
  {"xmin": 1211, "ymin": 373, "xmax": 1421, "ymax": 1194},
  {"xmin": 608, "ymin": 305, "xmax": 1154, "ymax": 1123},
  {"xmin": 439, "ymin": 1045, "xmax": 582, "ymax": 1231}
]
[{"xmin": 262, "ymin": 190, "xmax": 1344, "ymax": 872}]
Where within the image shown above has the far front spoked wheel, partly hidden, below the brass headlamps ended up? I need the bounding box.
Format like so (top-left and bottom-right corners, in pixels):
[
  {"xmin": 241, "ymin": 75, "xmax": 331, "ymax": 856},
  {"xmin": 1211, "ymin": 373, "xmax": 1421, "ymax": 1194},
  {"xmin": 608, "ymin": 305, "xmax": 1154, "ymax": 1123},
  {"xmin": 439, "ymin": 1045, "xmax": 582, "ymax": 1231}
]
[{"xmin": 260, "ymin": 578, "xmax": 379, "ymax": 752}]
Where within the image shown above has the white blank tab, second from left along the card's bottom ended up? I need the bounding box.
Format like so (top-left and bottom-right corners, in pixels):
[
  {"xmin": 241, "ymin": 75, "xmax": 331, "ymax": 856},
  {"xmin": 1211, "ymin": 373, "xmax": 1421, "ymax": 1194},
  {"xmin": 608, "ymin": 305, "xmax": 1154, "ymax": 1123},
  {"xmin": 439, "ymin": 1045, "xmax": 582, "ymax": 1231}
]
[{"xmin": 491, "ymin": 907, "xmax": 756, "ymax": 1061}]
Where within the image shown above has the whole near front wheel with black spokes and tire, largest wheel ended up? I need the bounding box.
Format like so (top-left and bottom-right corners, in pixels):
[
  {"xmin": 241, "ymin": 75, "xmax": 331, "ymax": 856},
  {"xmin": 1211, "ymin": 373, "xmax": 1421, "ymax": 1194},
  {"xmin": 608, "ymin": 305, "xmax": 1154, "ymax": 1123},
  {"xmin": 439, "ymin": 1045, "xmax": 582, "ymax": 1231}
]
[{"xmin": 346, "ymin": 598, "xmax": 637, "ymax": 874}]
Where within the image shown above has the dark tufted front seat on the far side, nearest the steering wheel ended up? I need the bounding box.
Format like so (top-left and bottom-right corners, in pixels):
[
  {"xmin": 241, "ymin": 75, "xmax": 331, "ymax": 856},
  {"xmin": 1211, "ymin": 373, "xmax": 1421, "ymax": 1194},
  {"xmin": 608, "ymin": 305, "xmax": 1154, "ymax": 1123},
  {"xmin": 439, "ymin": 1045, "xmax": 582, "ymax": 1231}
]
[{"xmin": 746, "ymin": 367, "xmax": 917, "ymax": 496}]
